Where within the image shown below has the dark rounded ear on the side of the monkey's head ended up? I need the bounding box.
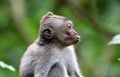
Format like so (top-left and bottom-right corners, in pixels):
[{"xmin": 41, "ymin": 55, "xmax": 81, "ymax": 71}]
[{"xmin": 41, "ymin": 28, "xmax": 54, "ymax": 40}]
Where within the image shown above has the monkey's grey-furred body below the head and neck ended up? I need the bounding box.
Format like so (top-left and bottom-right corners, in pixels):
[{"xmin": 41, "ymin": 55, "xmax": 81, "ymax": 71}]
[{"xmin": 20, "ymin": 41, "xmax": 82, "ymax": 77}]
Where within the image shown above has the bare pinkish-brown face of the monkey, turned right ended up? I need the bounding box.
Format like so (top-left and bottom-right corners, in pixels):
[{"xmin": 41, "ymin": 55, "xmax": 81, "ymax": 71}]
[{"xmin": 56, "ymin": 20, "xmax": 80, "ymax": 46}]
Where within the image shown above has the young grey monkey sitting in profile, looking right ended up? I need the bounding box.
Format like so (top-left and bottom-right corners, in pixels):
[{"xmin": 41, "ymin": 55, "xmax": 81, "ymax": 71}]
[{"xmin": 19, "ymin": 12, "xmax": 83, "ymax": 77}]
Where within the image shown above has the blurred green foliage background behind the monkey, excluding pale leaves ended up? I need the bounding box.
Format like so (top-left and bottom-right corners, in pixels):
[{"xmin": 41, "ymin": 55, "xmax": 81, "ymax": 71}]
[{"xmin": 0, "ymin": 0, "xmax": 120, "ymax": 77}]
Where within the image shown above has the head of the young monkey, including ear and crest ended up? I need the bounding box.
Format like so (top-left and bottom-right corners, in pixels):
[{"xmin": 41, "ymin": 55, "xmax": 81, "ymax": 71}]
[{"xmin": 40, "ymin": 12, "xmax": 80, "ymax": 47}]
